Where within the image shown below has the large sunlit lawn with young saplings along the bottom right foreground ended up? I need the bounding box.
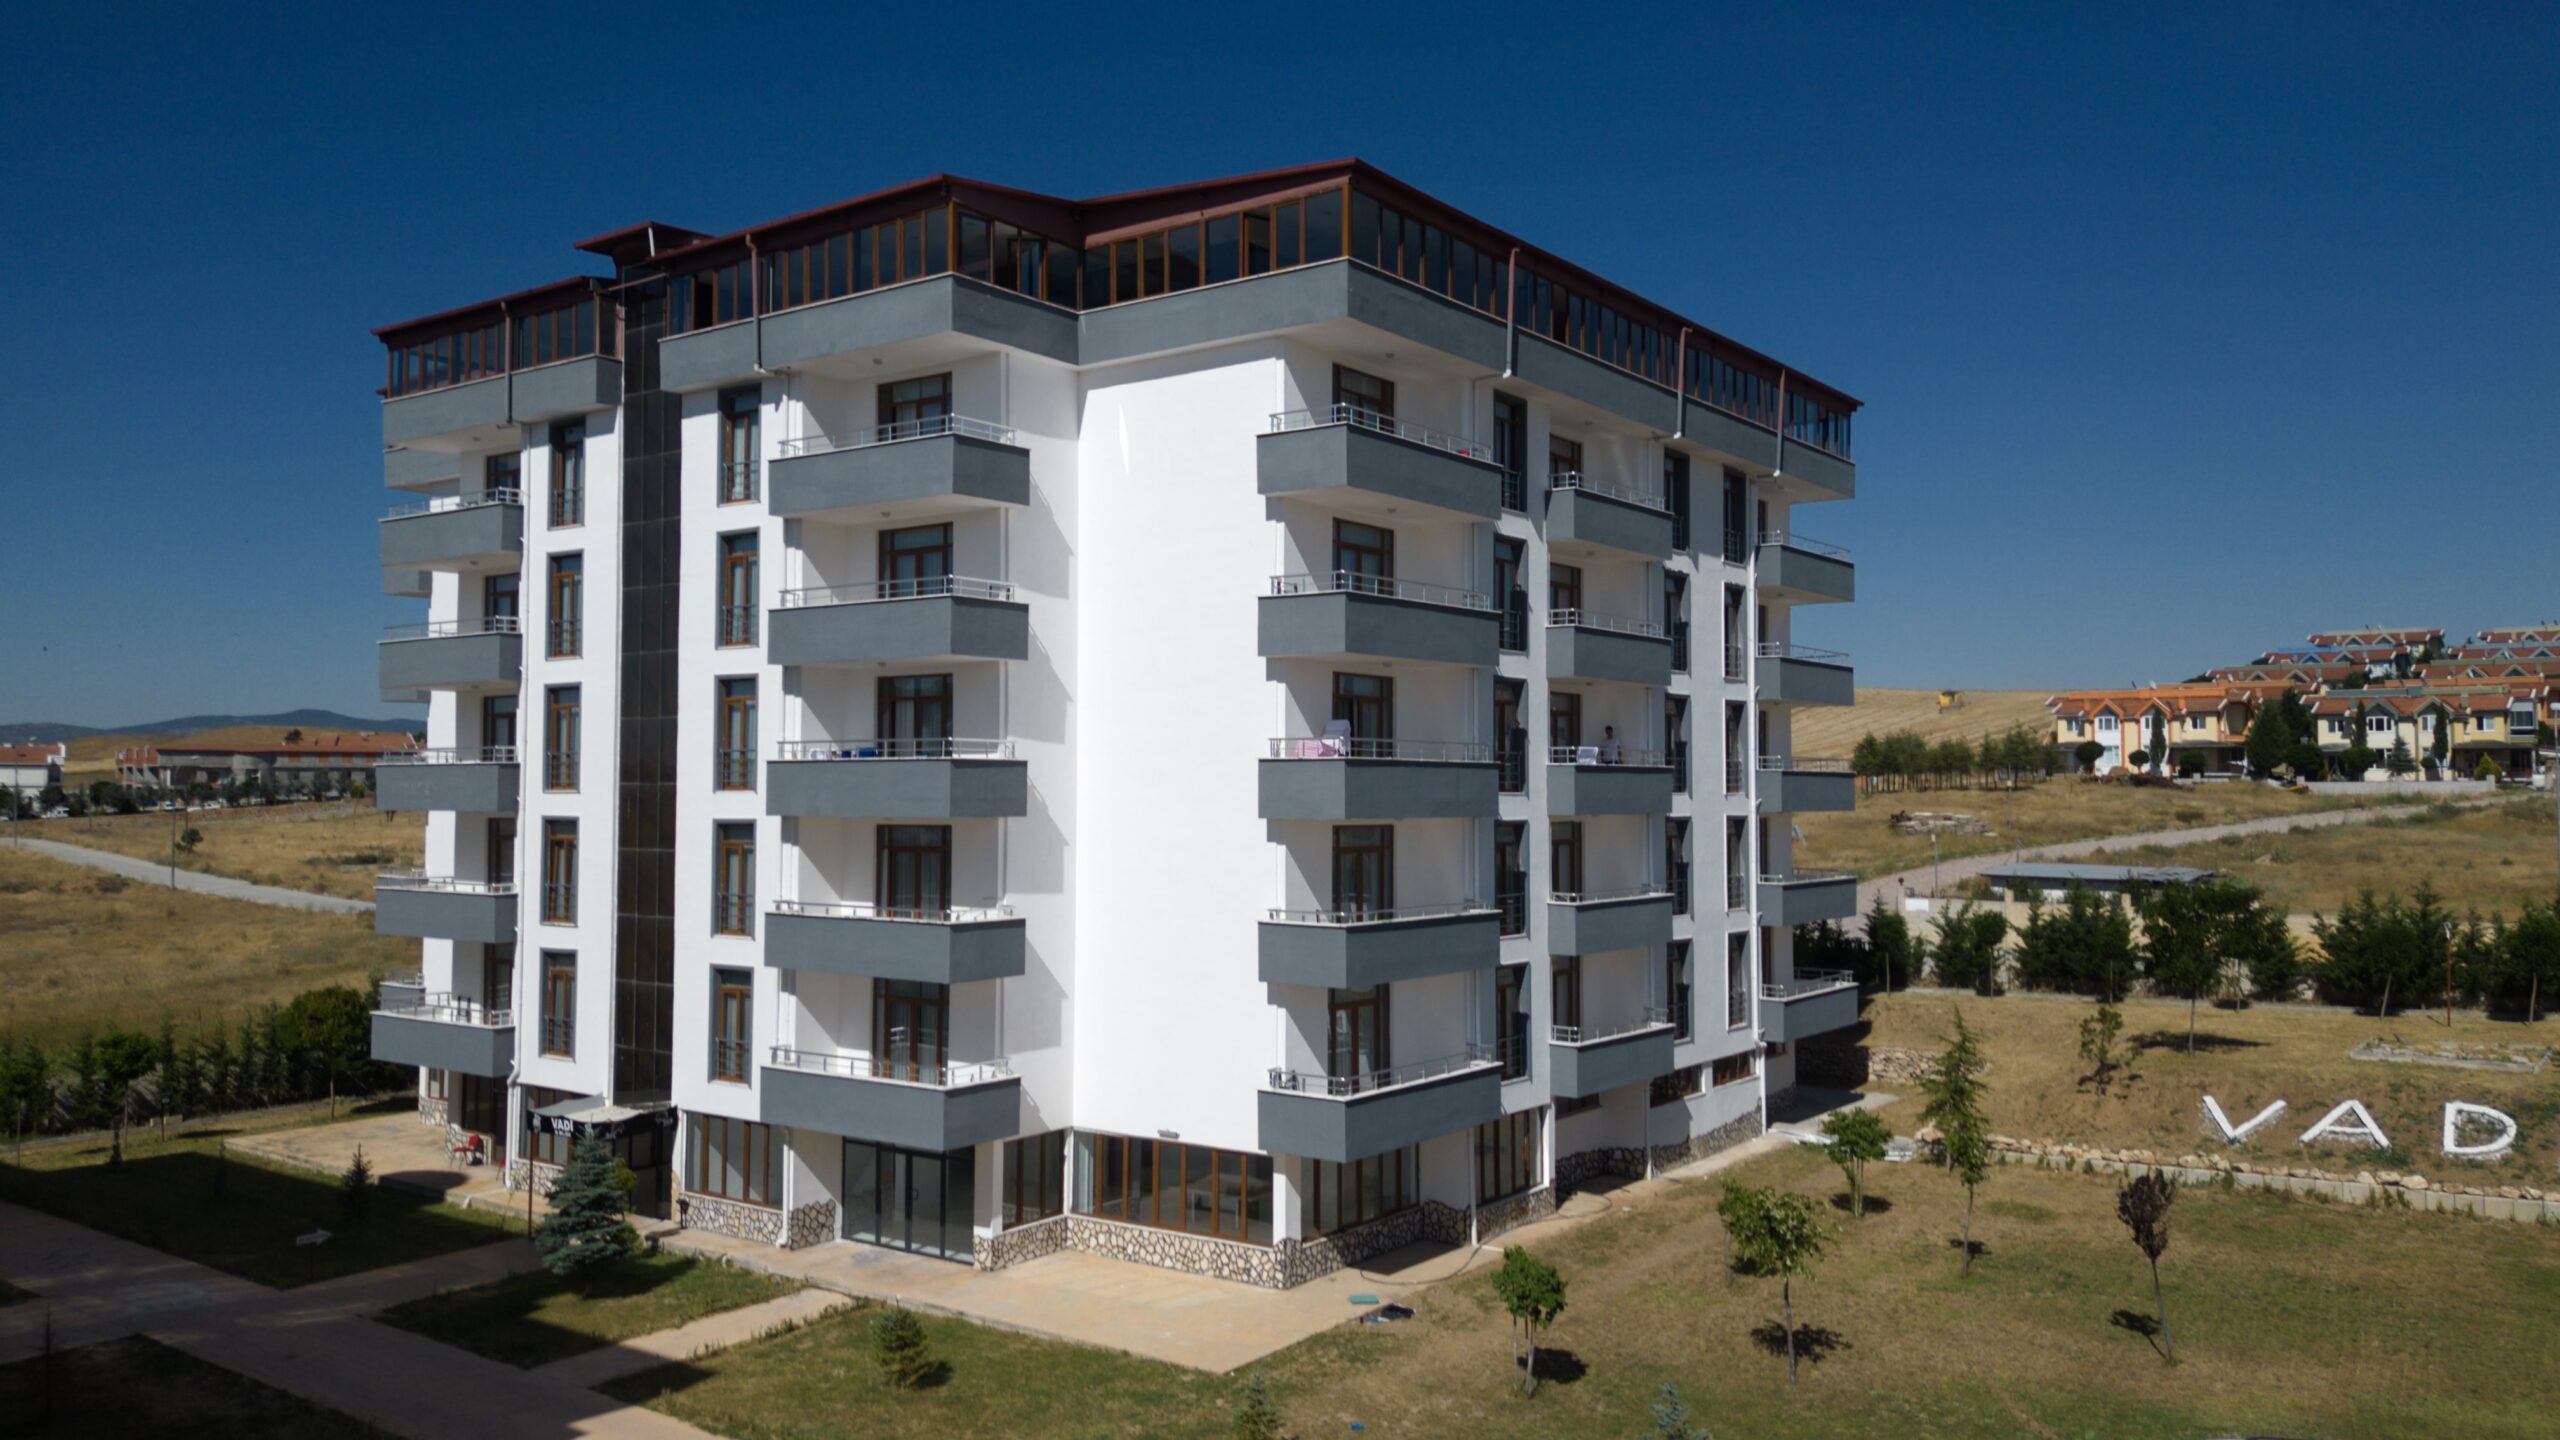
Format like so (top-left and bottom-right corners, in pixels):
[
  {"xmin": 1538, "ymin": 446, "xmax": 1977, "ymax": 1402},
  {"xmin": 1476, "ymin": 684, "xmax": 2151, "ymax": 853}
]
[{"xmin": 612, "ymin": 1150, "xmax": 2560, "ymax": 1440}]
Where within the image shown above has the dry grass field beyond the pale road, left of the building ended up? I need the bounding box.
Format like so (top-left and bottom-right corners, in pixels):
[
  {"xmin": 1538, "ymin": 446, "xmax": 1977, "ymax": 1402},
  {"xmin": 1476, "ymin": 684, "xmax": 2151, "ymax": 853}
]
[{"xmin": 28, "ymin": 799, "xmax": 428, "ymax": 899}]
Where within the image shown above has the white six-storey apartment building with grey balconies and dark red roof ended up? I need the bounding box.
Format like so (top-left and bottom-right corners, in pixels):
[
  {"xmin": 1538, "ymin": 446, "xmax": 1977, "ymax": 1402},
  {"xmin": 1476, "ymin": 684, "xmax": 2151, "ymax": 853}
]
[{"xmin": 374, "ymin": 161, "xmax": 1856, "ymax": 1286}]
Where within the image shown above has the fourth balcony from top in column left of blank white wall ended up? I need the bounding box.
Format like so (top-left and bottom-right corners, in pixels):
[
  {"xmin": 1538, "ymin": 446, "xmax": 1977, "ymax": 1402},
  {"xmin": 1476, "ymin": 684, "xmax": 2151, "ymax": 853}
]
[{"xmin": 765, "ymin": 899, "xmax": 1024, "ymax": 984}]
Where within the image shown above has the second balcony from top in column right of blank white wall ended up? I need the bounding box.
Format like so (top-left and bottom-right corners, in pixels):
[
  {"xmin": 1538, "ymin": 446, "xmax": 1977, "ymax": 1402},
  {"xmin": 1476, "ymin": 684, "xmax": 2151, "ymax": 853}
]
[{"xmin": 1257, "ymin": 569, "xmax": 1503, "ymax": 666}]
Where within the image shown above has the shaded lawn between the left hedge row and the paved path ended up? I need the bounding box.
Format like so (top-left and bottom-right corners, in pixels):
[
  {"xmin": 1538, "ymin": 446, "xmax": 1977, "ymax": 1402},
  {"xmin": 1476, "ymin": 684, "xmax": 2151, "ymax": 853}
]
[{"xmin": 0, "ymin": 1125, "xmax": 507, "ymax": 1289}]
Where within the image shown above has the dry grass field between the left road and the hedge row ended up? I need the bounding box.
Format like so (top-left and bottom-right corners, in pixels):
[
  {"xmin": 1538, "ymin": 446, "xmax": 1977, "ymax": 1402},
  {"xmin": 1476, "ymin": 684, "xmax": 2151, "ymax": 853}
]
[{"xmin": 0, "ymin": 843, "xmax": 417, "ymax": 1045}]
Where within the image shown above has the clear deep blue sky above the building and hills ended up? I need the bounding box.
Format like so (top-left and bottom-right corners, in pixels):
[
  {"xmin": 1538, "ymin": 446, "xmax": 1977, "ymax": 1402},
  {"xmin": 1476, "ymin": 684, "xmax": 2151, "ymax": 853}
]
[{"xmin": 0, "ymin": 5, "xmax": 2560, "ymax": 723}]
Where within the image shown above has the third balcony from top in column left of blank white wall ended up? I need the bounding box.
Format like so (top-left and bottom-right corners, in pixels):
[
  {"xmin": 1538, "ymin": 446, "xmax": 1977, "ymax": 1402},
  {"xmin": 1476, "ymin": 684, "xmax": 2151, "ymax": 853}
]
[{"xmin": 765, "ymin": 740, "xmax": 1032, "ymax": 820}]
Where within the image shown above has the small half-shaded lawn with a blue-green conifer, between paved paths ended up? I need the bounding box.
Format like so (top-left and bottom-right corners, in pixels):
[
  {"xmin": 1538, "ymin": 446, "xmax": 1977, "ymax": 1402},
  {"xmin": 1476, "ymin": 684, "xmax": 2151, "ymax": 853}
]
[{"xmin": 381, "ymin": 1256, "xmax": 799, "ymax": 1368}]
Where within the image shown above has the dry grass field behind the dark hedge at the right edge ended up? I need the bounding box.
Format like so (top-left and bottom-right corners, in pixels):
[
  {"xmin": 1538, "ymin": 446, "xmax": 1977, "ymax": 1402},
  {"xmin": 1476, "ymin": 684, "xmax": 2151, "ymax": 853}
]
[{"xmin": 2104, "ymin": 797, "xmax": 2560, "ymax": 915}]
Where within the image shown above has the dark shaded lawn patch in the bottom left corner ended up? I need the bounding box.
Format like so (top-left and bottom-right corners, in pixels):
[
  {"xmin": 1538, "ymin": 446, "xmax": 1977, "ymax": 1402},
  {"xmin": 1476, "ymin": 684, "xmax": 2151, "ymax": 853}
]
[{"xmin": 0, "ymin": 1335, "xmax": 379, "ymax": 1440}]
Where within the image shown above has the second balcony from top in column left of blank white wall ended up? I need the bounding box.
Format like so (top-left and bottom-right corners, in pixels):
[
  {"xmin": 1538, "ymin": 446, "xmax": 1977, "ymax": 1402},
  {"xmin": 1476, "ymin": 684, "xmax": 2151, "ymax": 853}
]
[{"xmin": 765, "ymin": 577, "xmax": 1032, "ymax": 666}]
